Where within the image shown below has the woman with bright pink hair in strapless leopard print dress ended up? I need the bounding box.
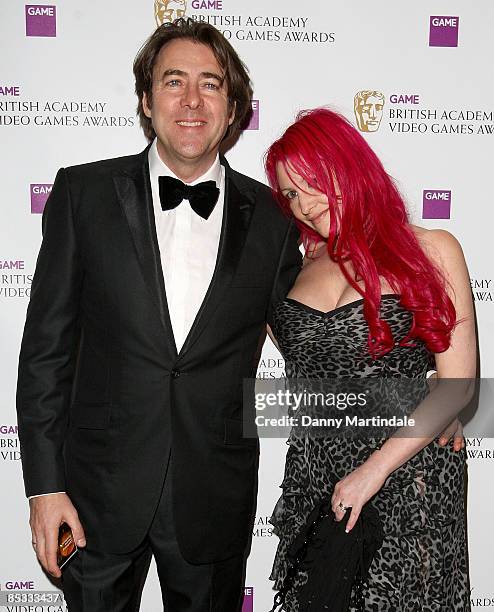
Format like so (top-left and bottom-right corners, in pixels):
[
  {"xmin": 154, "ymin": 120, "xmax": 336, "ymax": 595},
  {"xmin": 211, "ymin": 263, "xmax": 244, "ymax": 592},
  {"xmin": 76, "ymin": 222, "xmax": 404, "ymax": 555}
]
[{"xmin": 266, "ymin": 109, "xmax": 476, "ymax": 612}]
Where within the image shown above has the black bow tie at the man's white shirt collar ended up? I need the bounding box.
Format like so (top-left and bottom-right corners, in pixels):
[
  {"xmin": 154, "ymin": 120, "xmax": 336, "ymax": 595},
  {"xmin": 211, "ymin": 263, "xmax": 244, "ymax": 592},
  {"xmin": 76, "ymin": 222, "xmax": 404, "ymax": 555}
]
[{"xmin": 158, "ymin": 176, "xmax": 220, "ymax": 219}]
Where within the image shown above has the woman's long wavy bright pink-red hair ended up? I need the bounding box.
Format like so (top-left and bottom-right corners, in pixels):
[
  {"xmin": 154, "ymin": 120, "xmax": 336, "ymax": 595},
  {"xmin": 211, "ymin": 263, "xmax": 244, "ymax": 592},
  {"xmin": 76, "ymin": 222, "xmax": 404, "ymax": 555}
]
[{"xmin": 265, "ymin": 108, "xmax": 456, "ymax": 357}]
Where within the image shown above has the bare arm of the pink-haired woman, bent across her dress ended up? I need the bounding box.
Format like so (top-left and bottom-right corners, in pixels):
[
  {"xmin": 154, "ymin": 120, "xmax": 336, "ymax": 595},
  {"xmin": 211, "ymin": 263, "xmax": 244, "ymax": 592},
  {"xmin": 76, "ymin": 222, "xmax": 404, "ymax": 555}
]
[{"xmin": 332, "ymin": 230, "xmax": 476, "ymax": 531}]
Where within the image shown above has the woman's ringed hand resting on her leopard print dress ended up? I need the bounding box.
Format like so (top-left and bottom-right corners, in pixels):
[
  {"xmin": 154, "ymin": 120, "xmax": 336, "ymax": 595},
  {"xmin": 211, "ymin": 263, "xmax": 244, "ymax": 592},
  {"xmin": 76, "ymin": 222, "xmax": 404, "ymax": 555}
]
[{"xmin": 331, "ymin": 461, "xmax": 388, "ymax": 533}]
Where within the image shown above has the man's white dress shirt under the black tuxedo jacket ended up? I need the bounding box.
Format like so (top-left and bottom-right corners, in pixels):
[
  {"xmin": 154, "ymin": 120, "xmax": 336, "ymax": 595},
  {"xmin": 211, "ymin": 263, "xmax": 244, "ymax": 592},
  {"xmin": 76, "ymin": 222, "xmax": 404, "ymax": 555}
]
[{"xmin": 28, "ymin": 139, "xmax": 225, "ymax": 499}]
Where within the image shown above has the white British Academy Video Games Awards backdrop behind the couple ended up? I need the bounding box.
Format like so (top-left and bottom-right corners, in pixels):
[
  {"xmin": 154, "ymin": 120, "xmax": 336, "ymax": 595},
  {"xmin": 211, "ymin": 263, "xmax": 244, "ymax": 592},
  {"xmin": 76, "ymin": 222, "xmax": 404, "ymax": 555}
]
[{"xmin": 0, "ymin": 0, "xmax": 494, "ymax": 612}]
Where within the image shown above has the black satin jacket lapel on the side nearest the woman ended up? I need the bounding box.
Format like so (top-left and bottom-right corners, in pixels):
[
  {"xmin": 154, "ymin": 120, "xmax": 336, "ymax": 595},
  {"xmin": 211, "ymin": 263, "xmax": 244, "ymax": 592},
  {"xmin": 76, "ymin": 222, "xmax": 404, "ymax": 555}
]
[{"xmin": 180, "ymin": 157, "xmax": 254, "ymax": 356}]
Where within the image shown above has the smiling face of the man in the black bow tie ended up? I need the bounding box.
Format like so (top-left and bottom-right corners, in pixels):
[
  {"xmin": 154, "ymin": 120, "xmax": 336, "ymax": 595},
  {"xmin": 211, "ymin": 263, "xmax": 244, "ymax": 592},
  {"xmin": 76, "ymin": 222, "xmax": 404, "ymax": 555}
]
[{"xmin": 143, "ymin": 39, "xmax": 234, "ymax": 180}]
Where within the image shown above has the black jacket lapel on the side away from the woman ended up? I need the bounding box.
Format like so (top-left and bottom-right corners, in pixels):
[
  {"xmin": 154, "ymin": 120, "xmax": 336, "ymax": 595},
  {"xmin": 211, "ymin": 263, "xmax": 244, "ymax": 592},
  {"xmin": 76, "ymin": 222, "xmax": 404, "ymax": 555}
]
[{"xmin": 113, "ymin": 147, "xmax": 177, "ymax": 357}]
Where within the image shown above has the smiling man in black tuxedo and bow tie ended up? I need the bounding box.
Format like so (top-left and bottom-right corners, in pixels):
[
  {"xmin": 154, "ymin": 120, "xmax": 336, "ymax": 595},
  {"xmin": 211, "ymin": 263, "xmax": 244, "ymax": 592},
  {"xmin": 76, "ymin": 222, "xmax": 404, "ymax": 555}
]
[{"xmin": 18, "ymin": 20, "xmax": 300, "ymax": 612}]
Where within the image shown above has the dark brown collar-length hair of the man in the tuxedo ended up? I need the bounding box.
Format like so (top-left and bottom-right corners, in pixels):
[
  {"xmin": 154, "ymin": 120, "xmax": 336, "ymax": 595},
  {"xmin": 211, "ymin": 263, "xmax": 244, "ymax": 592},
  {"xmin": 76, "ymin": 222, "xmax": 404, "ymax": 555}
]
[{"xmin": 134, "ymin": 18, "xmax": 252, "ymax": 141}]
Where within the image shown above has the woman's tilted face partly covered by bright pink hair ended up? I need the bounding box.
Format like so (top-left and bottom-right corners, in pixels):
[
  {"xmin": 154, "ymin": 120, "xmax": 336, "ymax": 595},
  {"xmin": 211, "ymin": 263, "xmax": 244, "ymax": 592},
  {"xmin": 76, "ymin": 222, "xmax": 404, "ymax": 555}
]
[{"xmin": 276, "ymin": 162, "xmax": 330, "ymax": 239}]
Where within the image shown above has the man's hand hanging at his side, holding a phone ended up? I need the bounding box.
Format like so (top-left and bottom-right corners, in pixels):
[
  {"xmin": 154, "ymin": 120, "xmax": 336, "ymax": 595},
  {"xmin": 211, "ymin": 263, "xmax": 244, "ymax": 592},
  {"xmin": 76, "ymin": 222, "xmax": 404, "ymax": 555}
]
[{"xmin": 29, "ymin": 493, "xmax": 86, "ymax": 578}]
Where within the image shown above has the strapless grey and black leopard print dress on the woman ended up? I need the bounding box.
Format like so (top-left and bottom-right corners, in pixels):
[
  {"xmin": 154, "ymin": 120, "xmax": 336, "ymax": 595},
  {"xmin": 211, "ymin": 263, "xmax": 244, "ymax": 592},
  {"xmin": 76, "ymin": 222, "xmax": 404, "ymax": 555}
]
[{"xmin": 270, "ymin": 294, "xmax": 470, "ymax": 612}]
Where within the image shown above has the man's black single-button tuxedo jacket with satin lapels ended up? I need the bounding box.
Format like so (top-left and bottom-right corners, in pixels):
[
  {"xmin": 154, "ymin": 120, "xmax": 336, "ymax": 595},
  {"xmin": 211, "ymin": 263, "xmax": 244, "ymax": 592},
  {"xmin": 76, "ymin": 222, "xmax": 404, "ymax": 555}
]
[{"xmin": 17, "ymin": 149, "xmax": 300, "ymax": 563}]
